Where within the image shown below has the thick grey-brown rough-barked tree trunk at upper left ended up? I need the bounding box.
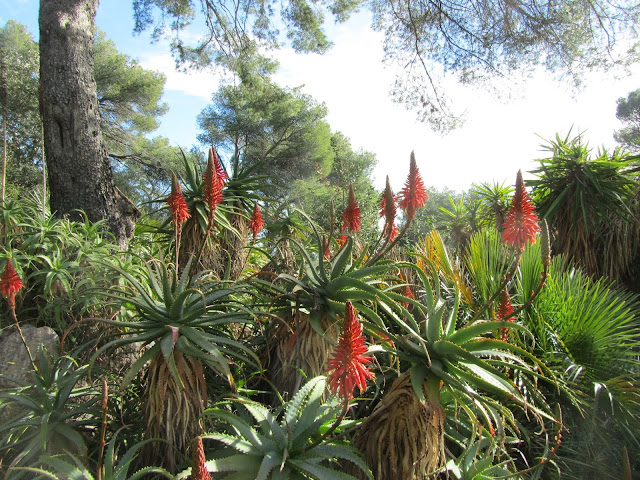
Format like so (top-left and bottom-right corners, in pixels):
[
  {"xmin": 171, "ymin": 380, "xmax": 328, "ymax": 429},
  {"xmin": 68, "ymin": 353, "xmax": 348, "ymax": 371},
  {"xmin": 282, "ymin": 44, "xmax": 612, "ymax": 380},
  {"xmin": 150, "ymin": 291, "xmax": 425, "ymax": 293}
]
[{"xmin": 40, "ymin": 0, "xmax": 140, "ymax": 246}]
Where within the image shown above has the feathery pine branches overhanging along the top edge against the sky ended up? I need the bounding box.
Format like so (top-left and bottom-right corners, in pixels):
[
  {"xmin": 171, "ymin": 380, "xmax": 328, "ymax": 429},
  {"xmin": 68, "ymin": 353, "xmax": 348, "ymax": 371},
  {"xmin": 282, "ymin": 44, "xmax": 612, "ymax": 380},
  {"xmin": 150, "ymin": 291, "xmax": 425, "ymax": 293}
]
[{"xmin": 134, "ymin": 0, "xmax": 640, "ymax": 130}]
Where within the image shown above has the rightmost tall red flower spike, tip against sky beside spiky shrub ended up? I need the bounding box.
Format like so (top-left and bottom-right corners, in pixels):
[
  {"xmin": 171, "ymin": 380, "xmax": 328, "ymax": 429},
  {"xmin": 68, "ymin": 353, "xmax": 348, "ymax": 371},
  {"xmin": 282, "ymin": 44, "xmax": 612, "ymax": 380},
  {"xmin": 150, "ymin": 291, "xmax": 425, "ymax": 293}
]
[{"xmin": 502, "ymin": 171, "xmax": 540, "ymax": 252}]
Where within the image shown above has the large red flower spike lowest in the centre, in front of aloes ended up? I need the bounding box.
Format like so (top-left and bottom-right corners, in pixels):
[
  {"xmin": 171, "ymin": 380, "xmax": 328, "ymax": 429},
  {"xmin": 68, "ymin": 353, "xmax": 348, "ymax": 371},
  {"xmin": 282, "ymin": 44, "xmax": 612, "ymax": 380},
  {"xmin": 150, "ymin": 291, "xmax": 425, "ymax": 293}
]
[{"xmin": 327, "ymin": 301, "xmax": 374, "ymax": 401}]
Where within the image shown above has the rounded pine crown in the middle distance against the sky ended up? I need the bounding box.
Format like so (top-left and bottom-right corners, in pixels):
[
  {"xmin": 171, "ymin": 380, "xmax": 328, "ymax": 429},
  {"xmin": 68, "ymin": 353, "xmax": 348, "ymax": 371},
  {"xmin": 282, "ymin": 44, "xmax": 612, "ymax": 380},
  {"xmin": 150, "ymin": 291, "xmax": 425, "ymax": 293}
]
[{"xmin": 198, "ymin": 56, "xmax": 333, "ymax": 193}]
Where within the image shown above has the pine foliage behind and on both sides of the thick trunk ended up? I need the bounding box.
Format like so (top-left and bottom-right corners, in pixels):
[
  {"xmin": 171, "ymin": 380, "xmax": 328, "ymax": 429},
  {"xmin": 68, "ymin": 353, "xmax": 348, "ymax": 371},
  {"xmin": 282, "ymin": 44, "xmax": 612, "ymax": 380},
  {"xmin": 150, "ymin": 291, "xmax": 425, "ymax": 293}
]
[{"xmin": 0, "ymin": 20, "xmax": 180, "ymax": 202}]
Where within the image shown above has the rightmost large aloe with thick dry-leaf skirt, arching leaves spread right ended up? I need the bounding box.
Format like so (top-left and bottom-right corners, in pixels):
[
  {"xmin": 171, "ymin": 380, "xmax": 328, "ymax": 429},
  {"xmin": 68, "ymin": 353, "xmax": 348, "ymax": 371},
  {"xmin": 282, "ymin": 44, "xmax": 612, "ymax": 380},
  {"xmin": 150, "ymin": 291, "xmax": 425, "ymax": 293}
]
[{"xmin": 354, "ymin": 248, "xmax": 555, "ymax": 480}]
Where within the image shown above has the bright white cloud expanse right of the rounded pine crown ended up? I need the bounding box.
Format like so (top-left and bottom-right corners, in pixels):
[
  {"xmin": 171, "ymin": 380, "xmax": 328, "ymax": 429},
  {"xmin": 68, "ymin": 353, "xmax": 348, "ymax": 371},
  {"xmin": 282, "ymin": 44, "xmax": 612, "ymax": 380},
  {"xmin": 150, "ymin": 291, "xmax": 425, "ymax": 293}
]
[{"xmin": 276, "ymin": 11, "xmax": 638, "ymax": 190}]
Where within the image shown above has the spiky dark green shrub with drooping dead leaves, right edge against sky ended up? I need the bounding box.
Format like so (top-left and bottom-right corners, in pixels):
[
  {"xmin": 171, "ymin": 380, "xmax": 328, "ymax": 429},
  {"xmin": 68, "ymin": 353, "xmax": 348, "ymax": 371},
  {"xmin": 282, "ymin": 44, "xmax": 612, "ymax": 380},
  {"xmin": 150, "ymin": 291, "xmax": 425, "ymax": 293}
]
[{"xmin": 529, "ymin": 131, "xmax": 640, "ymax": 280}]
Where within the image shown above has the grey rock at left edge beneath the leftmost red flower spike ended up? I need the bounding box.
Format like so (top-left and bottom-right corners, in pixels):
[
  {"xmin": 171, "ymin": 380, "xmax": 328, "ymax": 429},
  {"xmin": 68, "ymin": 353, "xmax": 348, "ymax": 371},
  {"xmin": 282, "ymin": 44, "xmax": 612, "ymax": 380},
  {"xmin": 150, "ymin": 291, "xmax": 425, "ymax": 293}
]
[{"xmin": 0, "ymin": 325, "xmax": 60, "ymax": 388}]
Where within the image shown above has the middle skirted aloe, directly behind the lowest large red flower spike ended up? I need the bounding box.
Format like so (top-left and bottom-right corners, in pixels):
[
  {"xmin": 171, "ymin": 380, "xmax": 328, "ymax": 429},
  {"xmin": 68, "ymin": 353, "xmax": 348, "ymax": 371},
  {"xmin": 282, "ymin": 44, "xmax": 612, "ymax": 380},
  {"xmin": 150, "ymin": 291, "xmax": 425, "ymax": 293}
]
[{"xmin": 257, "ymin": 232, "xmax": 395, "ymax": 395}]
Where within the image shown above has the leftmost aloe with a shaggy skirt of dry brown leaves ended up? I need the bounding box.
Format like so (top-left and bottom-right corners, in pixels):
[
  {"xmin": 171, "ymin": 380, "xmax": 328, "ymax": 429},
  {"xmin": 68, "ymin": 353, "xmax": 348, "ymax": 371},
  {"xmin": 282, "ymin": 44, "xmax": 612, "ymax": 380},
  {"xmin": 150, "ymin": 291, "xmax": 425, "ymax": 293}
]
[{"xmin": 94, "ymin": 262, "xmax": 257, "ymax": 471}]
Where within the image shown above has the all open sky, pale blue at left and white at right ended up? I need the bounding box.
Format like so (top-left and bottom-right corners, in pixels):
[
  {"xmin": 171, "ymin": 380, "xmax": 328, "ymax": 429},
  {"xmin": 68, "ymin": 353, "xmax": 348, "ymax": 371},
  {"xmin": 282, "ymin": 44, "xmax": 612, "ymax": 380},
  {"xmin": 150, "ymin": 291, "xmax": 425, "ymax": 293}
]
[{"xmin": 0, "ymin": 0, "xmax": 640, "ymax": 191}]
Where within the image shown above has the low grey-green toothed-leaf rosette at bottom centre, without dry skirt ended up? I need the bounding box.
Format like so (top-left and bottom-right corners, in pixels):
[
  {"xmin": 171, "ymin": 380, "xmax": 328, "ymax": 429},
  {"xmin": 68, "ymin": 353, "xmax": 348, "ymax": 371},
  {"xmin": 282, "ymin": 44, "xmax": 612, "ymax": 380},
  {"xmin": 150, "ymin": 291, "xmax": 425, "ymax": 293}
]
[{"xmin": 176, "ymin": 377, "xmax": 373, "ymax": 480}]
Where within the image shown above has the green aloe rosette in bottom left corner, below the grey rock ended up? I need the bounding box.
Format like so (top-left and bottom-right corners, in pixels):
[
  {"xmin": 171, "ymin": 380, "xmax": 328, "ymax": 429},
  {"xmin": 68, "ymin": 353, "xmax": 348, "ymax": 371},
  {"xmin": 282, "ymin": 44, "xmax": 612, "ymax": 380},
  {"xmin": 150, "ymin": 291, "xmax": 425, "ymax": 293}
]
[{"xmin": 0, "ymin": 349, "xmax": 99, "ymax": 478}]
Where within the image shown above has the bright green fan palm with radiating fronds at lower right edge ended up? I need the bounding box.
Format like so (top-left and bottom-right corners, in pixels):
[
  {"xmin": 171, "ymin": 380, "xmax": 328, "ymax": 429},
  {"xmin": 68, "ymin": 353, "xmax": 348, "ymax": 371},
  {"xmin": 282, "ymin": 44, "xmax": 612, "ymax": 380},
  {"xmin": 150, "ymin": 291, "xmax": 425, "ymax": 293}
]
[{"xmin": 520, "ymin": 248, "xmax": 640, "ymax": 478}]
